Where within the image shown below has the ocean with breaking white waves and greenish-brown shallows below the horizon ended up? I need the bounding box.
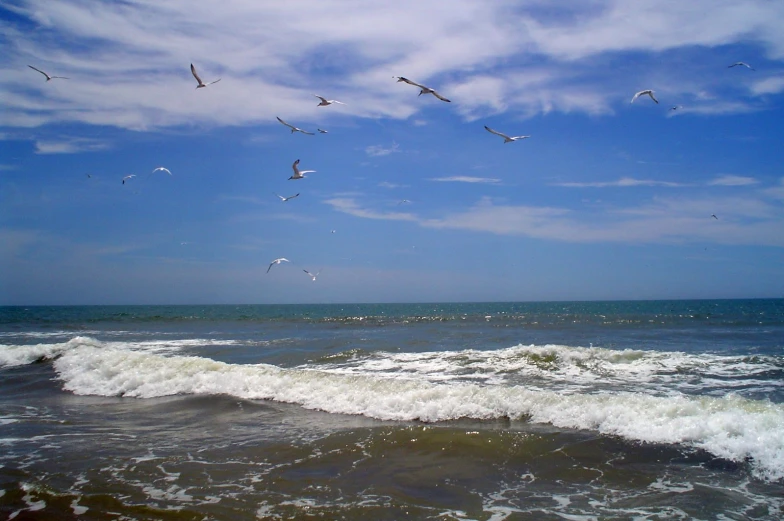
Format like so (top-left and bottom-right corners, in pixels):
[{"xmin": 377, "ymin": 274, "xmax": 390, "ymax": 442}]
[{"xmin": 0, "ymin": 299, "xmax": 784, "ymax": 521}]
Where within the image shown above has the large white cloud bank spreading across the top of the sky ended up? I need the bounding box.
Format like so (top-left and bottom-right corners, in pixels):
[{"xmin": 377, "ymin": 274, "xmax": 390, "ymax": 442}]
[{"xmin": 0, "ymin": 0, "xmax": 784, "ymax": 130}]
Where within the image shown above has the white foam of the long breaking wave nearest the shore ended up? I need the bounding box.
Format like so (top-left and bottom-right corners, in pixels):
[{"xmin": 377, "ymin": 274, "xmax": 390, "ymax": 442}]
[{"xmin": 54, "ymin": 345, "xmax": 784, "ymax": 479}]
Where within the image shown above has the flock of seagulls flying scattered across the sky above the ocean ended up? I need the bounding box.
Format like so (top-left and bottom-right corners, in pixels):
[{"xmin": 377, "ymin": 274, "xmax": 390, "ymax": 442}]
[{"xmin": 28, "ymin": 57, "xmax": 755, "ymax": 282}]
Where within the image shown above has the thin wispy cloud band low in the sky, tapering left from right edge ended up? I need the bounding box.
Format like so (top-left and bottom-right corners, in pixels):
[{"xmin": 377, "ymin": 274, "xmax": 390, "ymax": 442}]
[{"xmin": 327, "ymin": 193, "xmax": 784, "ymax": 246}]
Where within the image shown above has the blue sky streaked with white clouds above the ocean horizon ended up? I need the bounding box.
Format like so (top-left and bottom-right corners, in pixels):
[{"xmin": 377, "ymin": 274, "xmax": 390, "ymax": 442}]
[{"xmin": 0, "ymin": 0, "xmax": 784, "ymax": 304}]
